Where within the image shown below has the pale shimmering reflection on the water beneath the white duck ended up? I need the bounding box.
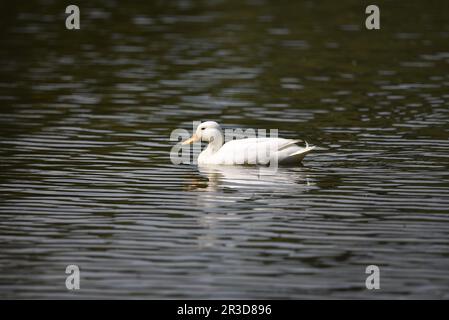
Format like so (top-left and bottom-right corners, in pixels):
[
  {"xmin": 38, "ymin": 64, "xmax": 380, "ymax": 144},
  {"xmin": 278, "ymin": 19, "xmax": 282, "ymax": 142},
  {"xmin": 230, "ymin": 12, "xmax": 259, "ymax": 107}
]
[{"xmin": 189, "ymin": 166, "xmax": 315, "ymax": 248}]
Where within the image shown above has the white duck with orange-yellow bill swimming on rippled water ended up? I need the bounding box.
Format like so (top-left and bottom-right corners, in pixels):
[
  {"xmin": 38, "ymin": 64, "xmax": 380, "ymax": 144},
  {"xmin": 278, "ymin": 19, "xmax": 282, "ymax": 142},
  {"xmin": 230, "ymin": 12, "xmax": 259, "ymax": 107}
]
[{"xmin": 182, "ymin": 121, "xmax": 315, "ymax": 165}]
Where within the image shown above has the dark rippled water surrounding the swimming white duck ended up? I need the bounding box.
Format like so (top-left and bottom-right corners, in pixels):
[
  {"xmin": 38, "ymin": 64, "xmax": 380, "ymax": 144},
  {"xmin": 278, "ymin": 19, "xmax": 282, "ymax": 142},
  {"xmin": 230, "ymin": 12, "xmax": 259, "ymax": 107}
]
[{"xmin": 0, "ymin": 0, "xmax": 449, "ymax": 299}]
